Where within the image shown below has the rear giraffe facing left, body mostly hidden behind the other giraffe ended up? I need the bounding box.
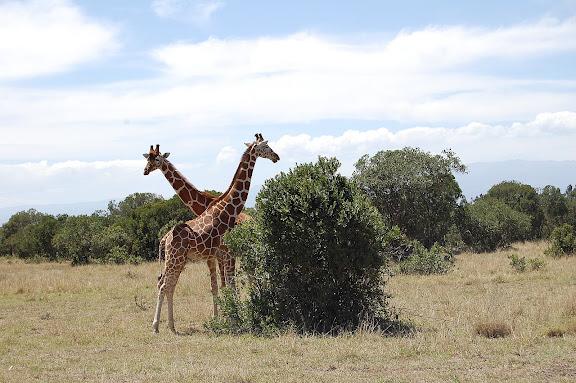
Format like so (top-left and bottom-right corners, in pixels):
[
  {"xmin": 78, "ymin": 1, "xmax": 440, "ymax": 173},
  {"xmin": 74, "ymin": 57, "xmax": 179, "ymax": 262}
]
[{"xmin": 143, "ymin": 144, "xmax": 250, "ymax": 288}]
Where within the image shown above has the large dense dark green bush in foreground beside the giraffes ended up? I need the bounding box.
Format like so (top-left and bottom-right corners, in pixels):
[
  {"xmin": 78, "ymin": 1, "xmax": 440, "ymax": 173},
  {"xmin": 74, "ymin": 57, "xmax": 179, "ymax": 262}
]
[{"xmin": 225, "ymin": 158, "xmax": 390, "ymax": 333}]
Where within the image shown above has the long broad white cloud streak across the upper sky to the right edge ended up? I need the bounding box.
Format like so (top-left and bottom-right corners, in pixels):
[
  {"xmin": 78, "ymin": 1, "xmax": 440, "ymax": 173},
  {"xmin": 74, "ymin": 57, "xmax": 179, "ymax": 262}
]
[{"xmin": 153, "ymin": 18, "xmax": 576, "ymax": 77}]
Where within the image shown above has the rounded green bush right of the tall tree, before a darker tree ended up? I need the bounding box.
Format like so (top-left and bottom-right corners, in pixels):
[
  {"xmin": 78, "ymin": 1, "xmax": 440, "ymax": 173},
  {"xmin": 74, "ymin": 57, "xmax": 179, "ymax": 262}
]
[{"xmin": 458, "ymin": 197, "xmax": 532, "ymax": 252}]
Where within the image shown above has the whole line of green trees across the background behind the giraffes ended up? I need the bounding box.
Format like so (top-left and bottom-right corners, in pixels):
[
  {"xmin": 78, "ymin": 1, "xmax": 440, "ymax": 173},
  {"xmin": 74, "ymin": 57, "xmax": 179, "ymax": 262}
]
[{"xmin": 0, "ymin": 148, "xmax": 576, "ymax": 264}]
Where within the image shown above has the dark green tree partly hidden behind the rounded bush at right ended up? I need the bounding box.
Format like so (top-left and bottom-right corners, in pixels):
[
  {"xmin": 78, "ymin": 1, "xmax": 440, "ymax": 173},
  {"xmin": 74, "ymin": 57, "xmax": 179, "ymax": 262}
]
[{"xmin": 486, "ymin": 181, "xmax": 544, "ymax": 239}]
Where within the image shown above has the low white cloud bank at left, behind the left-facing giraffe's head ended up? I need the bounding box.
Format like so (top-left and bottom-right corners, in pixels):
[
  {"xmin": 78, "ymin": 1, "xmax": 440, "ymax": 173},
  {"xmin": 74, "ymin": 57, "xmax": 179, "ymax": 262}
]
[{"xmin": 0, "ymin": 156, "xmax": 235, "ymax": 208}]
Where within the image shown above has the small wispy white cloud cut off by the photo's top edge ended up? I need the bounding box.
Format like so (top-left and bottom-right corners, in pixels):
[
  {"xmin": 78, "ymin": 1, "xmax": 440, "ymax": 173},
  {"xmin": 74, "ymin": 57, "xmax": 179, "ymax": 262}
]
[{"xmin": 152, "ymin": 0, "xmax": 224, "ymax": 25}]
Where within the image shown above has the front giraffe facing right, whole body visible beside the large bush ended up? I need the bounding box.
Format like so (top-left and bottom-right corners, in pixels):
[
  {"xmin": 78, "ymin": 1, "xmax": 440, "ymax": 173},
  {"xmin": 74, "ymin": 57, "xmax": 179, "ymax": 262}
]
[{"xmin": 152, "ymin": 134, "xmax": 280, "ymax": 333}]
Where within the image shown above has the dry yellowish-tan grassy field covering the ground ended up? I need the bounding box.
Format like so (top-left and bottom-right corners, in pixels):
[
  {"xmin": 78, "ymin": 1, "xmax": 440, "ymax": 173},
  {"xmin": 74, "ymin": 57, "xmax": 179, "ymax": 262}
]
[{"xmin": 0, "ymin": 243, "xmax": 576, "ymax": 383}]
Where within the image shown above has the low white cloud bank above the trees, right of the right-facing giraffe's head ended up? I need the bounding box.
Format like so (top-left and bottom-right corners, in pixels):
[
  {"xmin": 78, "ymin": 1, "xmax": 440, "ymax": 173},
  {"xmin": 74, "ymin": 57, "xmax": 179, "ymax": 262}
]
[{"xmin": 271, "ymin": 112, "xmax": 576, "ymax": 168}]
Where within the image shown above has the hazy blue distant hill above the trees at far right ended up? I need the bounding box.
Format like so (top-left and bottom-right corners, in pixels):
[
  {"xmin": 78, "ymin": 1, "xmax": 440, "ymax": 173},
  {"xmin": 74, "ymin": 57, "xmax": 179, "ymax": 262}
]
[{"xmin": 456, "ymin": 160, "xmax": 576, "ymax": 200}]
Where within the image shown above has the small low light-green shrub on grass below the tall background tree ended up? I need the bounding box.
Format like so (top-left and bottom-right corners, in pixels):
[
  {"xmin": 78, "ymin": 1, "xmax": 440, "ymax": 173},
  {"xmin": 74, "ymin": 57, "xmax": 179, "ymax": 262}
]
[{"xmin": 398, "ymin": 241, "xmax": 454, "ymax": 275}]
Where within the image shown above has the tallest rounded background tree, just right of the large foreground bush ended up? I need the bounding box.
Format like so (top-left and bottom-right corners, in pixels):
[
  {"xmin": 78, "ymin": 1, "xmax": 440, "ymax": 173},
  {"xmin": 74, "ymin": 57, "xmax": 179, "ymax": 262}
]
[{"xmin": 353, "ymin": 148, "xmax": 466, "ymax": 248}]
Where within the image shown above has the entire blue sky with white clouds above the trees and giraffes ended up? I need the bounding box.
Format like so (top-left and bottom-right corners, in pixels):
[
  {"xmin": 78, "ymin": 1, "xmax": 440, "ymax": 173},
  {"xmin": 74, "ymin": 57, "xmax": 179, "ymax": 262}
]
[{"xmin": 0, "ymin": 0, "xmax": 576, "ymax": 213}]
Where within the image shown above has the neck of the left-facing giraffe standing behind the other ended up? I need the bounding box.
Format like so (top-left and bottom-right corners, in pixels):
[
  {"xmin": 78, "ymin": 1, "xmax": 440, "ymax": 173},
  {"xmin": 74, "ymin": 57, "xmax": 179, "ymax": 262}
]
[{"xmin": 160, "ymin": 159, "xmax": 214, "ymax": 215}]
